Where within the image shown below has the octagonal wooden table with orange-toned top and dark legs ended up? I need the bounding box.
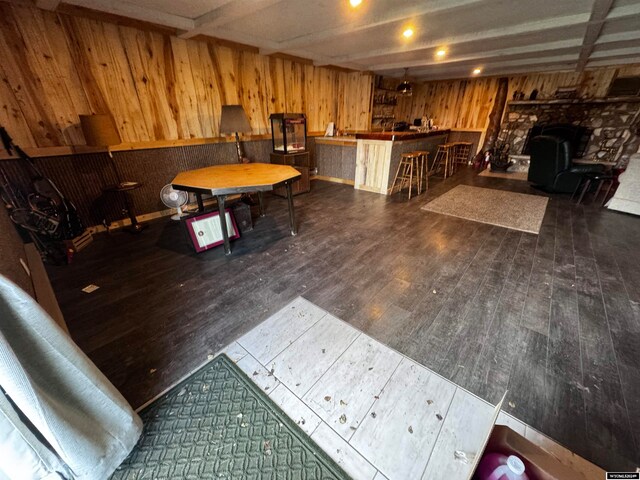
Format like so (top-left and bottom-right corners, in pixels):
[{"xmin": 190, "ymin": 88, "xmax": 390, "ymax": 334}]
[{"xmin": 171, "ymin": 163, "xmax": 301, "ymax": 255}]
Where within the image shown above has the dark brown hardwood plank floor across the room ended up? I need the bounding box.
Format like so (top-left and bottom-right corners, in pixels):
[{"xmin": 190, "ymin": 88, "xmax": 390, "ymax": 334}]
[{"xmin": 49, "ymin": 170, "xmax": 640, "ymax": 470}]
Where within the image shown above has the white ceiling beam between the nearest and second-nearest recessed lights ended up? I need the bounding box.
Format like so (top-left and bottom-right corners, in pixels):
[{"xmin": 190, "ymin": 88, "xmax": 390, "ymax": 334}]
[{"xmin": 258, "ymin": 0, "xmax": 483, "ymax": 54}]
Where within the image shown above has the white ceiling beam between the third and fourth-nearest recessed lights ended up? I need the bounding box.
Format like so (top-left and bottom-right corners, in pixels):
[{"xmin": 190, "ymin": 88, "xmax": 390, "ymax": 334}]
[{"xmin": 368, "ymin": 38, "xmax": 582, "ymax": 71}]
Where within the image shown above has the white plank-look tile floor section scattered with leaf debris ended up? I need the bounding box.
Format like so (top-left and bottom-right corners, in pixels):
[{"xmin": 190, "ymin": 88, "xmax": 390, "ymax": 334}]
[{"xmin": 220, "ymin": 297, "xmax": 596, "ymax": 480}]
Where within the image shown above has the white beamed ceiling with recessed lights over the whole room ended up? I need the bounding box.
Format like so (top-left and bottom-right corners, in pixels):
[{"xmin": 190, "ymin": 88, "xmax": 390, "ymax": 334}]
[{"xmin": 36, "ymin": 0, "xmax": 640, "ymax": 80}]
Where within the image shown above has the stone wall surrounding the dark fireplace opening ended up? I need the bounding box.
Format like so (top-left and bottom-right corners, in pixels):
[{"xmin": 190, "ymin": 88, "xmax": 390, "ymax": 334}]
[{"xmin": 500, "ymin": 99, "xmax": 640, "ymax": 167}]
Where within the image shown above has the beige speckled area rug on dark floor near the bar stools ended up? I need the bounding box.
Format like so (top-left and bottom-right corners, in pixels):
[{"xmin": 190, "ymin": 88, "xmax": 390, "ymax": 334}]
[{"xmin": 422, "ymin": 185, "xmax": 549, "ymax": 233}]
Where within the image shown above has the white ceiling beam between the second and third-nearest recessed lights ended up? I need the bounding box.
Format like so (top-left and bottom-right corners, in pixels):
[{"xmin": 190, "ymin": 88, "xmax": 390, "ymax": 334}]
[{"xmin": 334, "ymin": 13, "xmax": 589, "ymax": 62}]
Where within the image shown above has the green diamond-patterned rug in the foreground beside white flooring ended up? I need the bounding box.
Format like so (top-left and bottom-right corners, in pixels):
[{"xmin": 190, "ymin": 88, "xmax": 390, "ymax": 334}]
[{"xmin": 112, "ymin": 355, "xmax": 349, "ymax": 480}]
